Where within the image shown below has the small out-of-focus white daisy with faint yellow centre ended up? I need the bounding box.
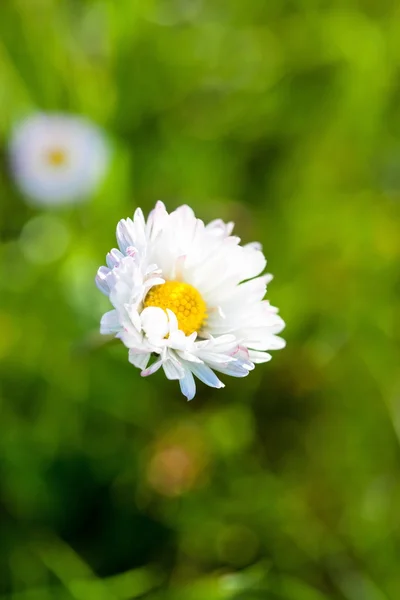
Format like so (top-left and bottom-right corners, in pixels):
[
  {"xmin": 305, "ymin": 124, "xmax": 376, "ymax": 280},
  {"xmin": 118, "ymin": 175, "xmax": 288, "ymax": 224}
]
[{"xmin": 10, "ymin": 113, "xmax": 109, "ymax": 206}]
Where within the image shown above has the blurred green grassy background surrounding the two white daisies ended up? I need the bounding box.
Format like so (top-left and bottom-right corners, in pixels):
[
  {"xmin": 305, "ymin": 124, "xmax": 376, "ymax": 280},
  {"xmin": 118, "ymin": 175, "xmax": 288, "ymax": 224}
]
[{"xmin": 0, "ymin": 0, "xmax": 400, "ymax": 600}]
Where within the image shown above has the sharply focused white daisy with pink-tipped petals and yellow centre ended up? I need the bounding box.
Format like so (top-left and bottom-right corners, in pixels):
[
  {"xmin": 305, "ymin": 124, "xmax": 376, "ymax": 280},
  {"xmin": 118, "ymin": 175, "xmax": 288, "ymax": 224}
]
[{"xmin": 96, "ymin": 202, "xmax": 285, "ymax": 400}]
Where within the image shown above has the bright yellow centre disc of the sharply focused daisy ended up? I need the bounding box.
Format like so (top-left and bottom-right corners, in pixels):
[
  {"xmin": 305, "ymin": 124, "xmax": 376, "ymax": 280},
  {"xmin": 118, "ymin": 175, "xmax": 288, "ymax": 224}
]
[{"xmin": 144, "ymin": 281, "xmax": 207, "ymax": 335}]
